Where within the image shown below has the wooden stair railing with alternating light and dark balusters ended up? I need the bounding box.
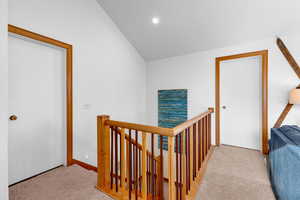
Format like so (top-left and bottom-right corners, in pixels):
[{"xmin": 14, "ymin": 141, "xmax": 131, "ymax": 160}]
[{"xmin": 96, "ymin": 108, "xmax": 214, "ymax": 200}]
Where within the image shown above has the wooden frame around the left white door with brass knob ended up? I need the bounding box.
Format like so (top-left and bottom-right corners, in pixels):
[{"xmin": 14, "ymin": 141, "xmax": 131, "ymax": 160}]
[{"xmin": 8, "ymin": 24, "xmax": 73, "ymax": 166}]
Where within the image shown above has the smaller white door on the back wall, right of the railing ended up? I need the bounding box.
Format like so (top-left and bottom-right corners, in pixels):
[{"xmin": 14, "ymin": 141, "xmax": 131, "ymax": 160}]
[{"xmin": 220, "ymin": 57, "xmax": 262, "ymax": 149}]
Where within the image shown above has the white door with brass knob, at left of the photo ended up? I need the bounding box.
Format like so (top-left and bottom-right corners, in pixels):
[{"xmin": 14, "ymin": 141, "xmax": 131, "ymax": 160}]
[{"xmin": 8, "ymin": 34, "xmax": 66, "ymax": 185}]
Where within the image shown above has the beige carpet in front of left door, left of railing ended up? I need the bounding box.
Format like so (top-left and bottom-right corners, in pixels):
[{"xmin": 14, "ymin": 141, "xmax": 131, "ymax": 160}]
[{"xmin": 9, "ymin": 165, "xmax": 111, "ymax": 200}]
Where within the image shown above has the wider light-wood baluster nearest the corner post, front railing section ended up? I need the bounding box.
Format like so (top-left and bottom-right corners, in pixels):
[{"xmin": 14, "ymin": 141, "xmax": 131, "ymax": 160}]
[{"xmin": 142, "ymin": 132, "xmax": 148, "ymax": 200}]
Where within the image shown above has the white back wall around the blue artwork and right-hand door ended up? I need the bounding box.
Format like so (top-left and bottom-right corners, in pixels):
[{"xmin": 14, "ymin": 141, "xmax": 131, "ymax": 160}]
[{"xmin": 147, "ymin": 35, "xmax": 300, "ymax": 144}]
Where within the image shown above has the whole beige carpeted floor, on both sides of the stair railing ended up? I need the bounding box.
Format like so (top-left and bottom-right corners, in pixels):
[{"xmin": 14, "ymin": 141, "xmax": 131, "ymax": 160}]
[{"xmin": 9, "ymin": 146, "xmax": 275, "ymax": 200}]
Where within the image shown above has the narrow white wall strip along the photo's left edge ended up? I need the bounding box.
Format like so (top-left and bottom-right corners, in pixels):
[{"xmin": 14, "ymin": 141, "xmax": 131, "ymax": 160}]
[{"xmin": 0, "ymin": 0, "xmax": 8, "ymax": 200}]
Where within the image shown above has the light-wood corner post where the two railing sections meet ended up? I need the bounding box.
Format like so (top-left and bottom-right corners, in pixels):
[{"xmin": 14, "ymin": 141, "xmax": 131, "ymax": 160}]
[{"xmin": 168, "ymin": 137, "xmax": 175, "ymax": 200}]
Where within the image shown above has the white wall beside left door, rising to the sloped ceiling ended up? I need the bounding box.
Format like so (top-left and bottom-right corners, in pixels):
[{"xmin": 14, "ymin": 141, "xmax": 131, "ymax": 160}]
[{"xmin": 9, "ymin": 0, "xmax": 146, "ymax": 165}]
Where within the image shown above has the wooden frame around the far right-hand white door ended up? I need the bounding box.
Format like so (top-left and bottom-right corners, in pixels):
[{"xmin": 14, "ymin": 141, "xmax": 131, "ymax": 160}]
[{"xmin": 215, "ymin": 50, "xmax": 269, "ymax": 154}]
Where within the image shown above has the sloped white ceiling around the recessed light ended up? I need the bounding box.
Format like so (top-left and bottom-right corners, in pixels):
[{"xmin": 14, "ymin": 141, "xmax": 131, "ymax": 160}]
[{"xmin": 97, "ymin": 0, "xmax": 300, "ymax": 61}]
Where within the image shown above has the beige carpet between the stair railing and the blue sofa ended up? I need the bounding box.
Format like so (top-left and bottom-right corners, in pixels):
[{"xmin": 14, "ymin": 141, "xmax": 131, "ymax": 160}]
[{"xmin": 196, "ymin": 145, "xmax": 275, "ymax": 200}]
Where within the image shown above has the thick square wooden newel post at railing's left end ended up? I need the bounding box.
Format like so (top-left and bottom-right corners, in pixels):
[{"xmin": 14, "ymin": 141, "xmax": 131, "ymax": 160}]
[{"xmin": 96, "ymin": 115, "xmax": 110, "ymax": 189}]
